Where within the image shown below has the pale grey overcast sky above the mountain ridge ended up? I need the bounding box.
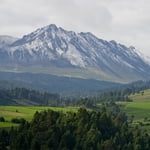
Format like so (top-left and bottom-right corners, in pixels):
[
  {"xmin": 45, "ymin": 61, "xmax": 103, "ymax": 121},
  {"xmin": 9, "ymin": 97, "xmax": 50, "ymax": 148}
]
[{"xmin": 0, "ymin": 0, "xmax": 150, "ymax": 56}]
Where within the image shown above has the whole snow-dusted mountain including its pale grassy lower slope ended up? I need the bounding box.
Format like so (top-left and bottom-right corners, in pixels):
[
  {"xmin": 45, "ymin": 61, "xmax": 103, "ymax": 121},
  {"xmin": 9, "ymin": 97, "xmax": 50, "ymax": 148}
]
[{"xmin": 0, "ymin": 24, "xmax": 150, "ymax": 82}]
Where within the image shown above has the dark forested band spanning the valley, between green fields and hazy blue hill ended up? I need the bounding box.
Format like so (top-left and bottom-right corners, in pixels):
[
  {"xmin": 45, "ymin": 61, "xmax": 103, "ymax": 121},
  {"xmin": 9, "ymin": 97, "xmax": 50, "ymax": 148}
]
[{"xmin": 0, "ymin": 81, "xmax": 150, "ymax": 108}]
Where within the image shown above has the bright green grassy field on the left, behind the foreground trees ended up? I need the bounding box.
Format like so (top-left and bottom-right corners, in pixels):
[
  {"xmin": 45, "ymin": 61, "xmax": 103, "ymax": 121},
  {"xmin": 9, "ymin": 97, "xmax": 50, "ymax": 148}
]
[{"xmin": 0, "ymin": 106, "xmax": 78, "ymax": 128}]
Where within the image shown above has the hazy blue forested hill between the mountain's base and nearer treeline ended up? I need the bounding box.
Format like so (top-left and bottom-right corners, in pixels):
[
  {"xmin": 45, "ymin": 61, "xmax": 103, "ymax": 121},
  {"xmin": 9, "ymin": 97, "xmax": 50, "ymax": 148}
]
[{"xmin": 0, "ymin": 72, "xmax": 122, "ymax": 97}]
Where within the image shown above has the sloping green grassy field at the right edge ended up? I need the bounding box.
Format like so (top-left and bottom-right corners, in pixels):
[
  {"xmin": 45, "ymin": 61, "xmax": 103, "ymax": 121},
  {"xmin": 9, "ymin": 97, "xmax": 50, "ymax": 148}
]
[{"xmin": 118, "ymin": 90, "xmax": 150, "ymax": 131}]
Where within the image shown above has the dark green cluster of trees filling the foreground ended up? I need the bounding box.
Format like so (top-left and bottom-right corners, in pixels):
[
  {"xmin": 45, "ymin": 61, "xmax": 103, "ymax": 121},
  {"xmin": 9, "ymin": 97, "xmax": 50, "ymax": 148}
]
[{"xmin": 0, "ymin": 108, "xmax": 150, "ymax": 150}]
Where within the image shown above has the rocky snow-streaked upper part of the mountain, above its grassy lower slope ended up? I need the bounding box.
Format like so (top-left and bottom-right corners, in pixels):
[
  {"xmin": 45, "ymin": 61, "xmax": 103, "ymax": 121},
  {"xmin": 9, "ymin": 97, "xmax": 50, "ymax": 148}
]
[{"xmin": 0, "ymin": 24, "xmax": 150, "ymax": 82}]
